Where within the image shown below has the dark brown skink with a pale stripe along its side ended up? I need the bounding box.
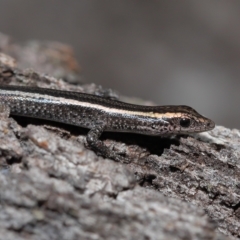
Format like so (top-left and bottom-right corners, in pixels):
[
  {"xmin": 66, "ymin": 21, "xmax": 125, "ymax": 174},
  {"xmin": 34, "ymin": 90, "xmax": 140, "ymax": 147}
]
[{"xmin": 0, "ymin": 85, "xmax": 215, "ymax": 162}]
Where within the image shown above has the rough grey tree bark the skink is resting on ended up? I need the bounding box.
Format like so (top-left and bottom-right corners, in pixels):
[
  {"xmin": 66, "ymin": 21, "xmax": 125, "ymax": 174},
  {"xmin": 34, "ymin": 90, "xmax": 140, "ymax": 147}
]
[{"xmin": 0, "ymin": 34, "xmax": 240, "ymax": 240}]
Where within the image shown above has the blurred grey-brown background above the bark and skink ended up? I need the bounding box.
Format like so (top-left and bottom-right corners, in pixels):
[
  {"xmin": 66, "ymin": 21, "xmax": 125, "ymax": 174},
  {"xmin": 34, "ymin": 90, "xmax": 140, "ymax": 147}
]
[{"xmin": 0, "ymin": 0, "xmax": 240, "ymax": 129}]
